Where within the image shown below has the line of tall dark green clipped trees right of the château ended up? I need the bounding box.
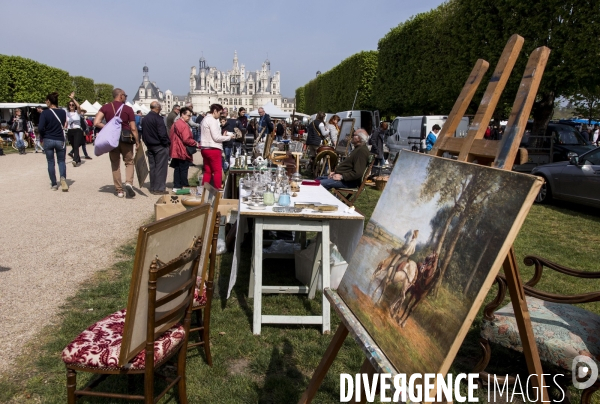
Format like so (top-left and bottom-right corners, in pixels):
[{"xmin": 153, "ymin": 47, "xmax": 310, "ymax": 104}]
[{"xmin": 297, "ymin": 0, "xmax": 600, "ymax": 126}]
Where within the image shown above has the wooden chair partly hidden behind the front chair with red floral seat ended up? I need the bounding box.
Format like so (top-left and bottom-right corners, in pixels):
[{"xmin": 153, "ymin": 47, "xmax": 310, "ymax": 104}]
[{"xmin": 188, "ymin": 213, "xmax": 221, "ymax": 366}]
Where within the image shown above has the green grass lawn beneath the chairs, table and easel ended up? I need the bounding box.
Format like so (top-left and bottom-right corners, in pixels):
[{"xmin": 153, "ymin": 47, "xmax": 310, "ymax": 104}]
[{"xmin": 0, "ymin": 189, "xmax": 600, "ymax": 403}]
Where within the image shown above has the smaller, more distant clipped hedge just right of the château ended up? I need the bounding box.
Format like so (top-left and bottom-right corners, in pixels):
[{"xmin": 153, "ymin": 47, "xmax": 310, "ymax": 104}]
[{"xmin": 302, "ymin": 51, "xmax": 377, "ymax": 114}]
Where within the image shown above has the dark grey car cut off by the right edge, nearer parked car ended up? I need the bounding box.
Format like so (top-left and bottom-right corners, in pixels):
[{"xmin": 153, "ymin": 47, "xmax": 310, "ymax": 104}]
[{"xmin": 531, "ymin": 147, "xmax": 600, "ymax": 207}]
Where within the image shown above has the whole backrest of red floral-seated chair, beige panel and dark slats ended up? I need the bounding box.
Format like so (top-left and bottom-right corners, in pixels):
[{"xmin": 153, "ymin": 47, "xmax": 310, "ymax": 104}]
[{"xmin": 119, "ymin": 204, "xmax": 210, "ymax": 366}]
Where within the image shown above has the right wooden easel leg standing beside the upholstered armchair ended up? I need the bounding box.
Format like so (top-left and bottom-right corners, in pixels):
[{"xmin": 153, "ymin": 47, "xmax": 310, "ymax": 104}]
[{"xmin": 503, "ymin": 247, "xmax": 548, "ymax": 402}]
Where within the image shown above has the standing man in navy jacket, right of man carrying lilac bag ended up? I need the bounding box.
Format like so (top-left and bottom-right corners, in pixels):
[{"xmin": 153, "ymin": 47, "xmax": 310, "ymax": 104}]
[{"xmin": 142, "ymin": 101, "xmax": 171, "ymax": 195}]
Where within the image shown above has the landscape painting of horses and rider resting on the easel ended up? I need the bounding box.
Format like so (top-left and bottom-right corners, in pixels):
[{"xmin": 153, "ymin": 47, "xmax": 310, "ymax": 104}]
[{"xmin": 338, "ymin": 151, "xmax": 541, "ymax": 374}]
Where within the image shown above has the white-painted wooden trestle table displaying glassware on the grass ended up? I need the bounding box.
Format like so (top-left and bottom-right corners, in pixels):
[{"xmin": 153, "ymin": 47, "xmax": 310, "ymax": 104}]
[{"xmin": 227, "ymin": 185, "xmax": 364, "ymax": 335}]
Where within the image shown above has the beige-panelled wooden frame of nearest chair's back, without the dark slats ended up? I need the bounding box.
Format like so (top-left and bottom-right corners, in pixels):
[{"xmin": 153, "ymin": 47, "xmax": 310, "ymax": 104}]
[{"xmin": 119, "ymin": 205, "xmax": 210, "ymax": 366}]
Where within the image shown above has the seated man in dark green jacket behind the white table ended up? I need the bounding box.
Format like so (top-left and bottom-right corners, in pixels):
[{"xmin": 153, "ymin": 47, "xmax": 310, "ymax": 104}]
[{"xmin": 317, "ymin": 129, "xmax": 369, "ymax": 189}]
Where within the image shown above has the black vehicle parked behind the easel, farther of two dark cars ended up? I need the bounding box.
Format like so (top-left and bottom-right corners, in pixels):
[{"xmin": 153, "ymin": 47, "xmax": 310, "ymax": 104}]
[{"xmin": 513, "ymin": 122, "xmax": 595, "ymax": 173}]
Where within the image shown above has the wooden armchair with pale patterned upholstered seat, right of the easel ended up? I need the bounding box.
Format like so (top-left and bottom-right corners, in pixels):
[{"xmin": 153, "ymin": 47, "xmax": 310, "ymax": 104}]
[{"xmin": 474, "ymin": 255, "xmax": 600, "ymax": 404}]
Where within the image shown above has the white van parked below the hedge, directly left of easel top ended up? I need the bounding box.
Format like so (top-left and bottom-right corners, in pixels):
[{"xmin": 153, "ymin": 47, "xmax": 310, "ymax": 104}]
[{"xmin": 386, "ymin": 115, "xmax": 469, "ymax": 153}]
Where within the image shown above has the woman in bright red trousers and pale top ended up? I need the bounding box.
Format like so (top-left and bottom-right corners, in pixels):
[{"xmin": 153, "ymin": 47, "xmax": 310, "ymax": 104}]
[{"xmin": 200, "ymin": 104, "xmax": 232, "ymax": 189}]
